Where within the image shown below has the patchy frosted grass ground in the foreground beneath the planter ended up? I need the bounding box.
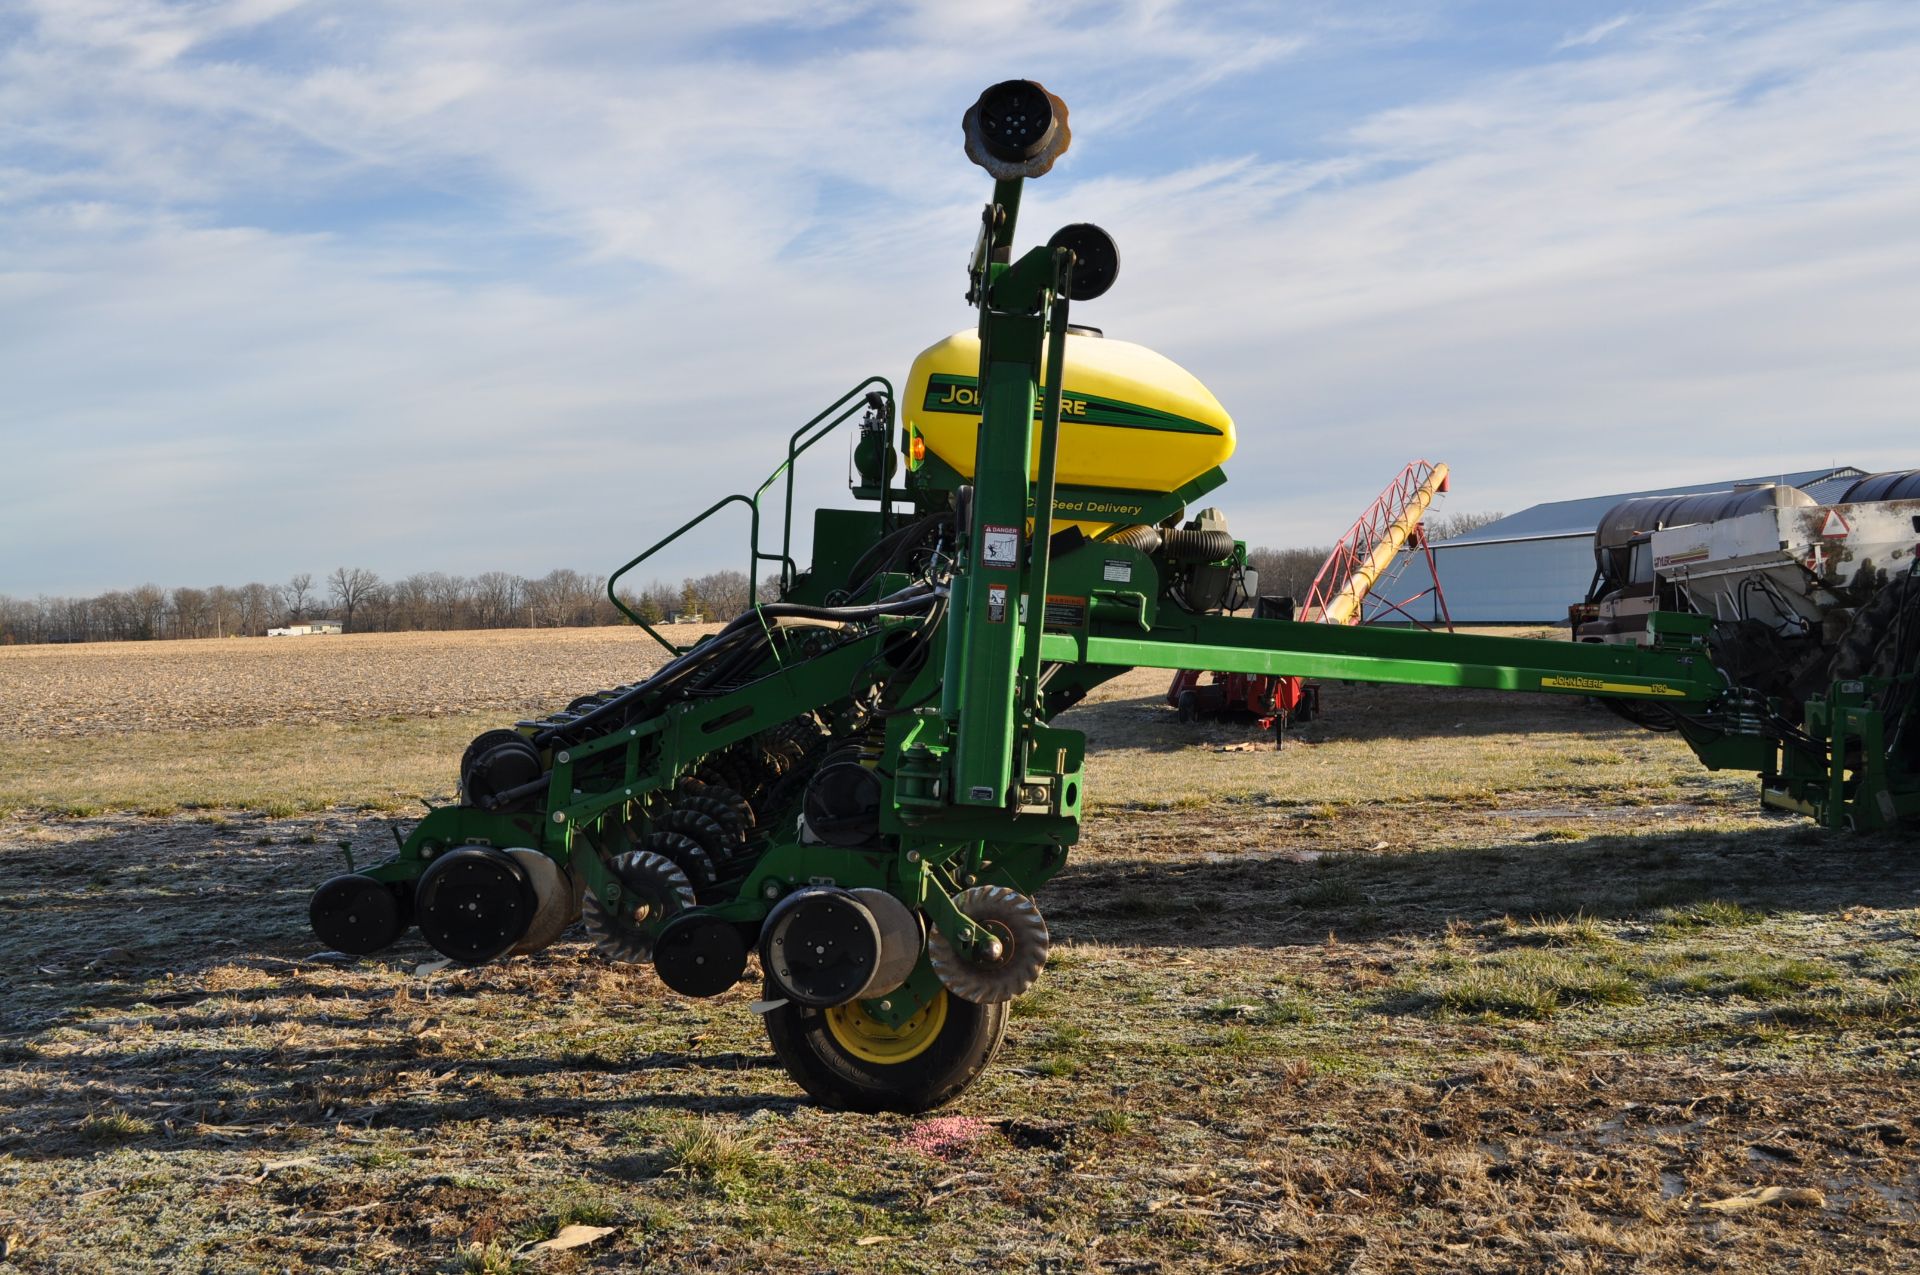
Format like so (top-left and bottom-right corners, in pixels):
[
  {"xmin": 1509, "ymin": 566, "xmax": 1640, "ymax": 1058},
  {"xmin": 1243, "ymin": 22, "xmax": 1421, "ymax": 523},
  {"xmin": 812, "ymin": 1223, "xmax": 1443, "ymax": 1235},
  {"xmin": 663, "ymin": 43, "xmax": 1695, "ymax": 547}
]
[{"xmin": 0, "ymin": 633, "xmax": 1920, "ymax": 1275}]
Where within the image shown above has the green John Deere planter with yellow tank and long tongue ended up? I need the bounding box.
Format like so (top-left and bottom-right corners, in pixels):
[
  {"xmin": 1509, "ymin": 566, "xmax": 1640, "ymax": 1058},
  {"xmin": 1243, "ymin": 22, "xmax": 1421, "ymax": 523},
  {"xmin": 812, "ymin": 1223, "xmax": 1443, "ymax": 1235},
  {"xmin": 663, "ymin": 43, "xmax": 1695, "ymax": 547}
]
[{"xmin": 311, "ymin": 81, "xmax": 1920, "ymax": 1110}]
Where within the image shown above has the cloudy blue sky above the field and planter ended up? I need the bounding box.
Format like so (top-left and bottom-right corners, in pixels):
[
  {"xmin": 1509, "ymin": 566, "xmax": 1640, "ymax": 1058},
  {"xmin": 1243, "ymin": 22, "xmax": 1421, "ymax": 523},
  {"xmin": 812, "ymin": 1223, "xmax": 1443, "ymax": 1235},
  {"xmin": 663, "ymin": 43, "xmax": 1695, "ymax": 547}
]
[{"xmin": 0, "ymin": 0, "xmax": 1920, "ymax": 597}]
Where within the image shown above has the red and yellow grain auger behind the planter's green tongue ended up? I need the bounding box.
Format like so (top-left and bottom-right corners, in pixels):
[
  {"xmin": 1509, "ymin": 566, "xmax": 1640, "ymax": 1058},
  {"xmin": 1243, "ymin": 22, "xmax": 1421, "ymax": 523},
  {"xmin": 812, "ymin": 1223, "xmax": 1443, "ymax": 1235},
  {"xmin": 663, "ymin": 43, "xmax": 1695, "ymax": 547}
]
[{"xmin": 1167, "ymin": 461, "xmax": 1453, "ymax": 747}]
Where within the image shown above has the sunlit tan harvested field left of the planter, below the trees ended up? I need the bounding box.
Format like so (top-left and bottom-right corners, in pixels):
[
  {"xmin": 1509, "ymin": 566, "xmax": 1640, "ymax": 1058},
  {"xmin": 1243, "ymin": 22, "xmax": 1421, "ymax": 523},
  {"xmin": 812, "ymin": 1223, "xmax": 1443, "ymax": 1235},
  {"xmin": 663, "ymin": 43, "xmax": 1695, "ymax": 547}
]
[{"xmin": 0, "ymin": 626, "xmax": 710, "ymax": 814}]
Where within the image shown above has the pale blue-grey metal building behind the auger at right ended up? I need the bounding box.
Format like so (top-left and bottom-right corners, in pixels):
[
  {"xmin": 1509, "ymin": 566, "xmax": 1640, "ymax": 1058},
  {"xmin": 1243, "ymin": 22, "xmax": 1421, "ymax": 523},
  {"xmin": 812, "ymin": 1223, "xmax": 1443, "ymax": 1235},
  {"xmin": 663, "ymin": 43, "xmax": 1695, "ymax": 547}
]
[{"xmin": 1394, "ymin": 465, "xmax": 1866, "ymax": 624}]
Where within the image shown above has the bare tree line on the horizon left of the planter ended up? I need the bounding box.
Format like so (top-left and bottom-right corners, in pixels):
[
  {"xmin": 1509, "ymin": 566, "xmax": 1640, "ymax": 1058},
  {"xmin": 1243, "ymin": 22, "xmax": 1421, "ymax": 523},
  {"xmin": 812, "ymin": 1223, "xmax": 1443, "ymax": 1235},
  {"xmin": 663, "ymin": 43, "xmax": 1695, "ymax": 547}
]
[{"xmin": 0, "ymin": 566, "xmax": 778, "ymax": 645}]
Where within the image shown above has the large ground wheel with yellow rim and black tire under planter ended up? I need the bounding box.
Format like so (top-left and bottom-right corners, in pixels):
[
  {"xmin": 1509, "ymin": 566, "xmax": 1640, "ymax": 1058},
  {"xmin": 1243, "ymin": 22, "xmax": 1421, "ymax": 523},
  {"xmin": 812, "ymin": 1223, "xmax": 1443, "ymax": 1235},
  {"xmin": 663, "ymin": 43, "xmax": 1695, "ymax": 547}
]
[{"xmin": 764, "ymin": 985, "xmax": 1006, "ymax": 1112}]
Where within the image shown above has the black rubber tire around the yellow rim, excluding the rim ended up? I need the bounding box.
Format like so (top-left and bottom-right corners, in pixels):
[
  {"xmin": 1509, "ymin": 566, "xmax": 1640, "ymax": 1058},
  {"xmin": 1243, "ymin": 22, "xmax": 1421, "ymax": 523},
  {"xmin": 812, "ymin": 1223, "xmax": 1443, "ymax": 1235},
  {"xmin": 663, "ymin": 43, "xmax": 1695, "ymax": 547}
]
[{"xmin": 762, "ymin": 985, "xmax": 1006, "ymax": 1114}]
